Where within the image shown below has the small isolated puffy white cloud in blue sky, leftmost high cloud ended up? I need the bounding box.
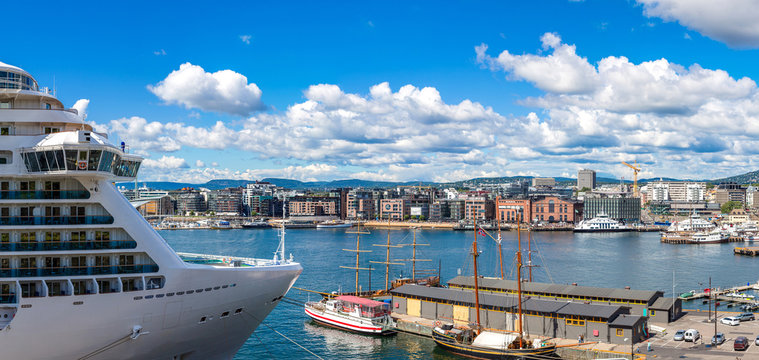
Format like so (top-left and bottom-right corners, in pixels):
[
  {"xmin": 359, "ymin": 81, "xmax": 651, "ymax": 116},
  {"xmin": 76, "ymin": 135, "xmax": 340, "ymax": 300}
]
[{"xmin": 148, "ymin": 63, "xmax": 265, "ymax": 116}]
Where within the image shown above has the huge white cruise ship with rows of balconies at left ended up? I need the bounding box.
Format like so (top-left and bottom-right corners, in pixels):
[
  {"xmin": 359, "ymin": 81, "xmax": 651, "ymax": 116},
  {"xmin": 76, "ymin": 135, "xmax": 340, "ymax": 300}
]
[{"xmin": 0, "ymin": 63, "xmax": 302, "ymax": 360}]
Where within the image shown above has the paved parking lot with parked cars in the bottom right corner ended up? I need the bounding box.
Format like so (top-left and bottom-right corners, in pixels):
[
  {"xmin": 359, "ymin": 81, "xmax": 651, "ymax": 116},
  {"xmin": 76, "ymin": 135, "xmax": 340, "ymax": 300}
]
[{"xmin": 648, "ymin": 312, "xmax": 759, "ymax": 360}]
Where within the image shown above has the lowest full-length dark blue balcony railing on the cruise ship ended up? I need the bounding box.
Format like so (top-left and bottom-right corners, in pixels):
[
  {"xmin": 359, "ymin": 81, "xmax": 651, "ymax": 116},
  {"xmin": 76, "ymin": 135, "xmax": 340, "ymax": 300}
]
[{"xmin": 0, "ymin": 264, "xmax": 158, "ymax": 278}]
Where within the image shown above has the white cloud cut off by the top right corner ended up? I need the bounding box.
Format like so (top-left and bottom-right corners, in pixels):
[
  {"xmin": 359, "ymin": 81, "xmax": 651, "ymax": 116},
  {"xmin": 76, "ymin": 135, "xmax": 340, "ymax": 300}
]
[{"xmin": 637, "ymin": 0, "xmax": 759, "ymax": 48}]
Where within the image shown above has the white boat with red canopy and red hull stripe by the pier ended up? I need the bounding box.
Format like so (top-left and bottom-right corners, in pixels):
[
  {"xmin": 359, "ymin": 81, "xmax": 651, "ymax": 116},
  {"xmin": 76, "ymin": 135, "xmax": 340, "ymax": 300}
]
[{"xmin": 306, "ymin": 295, "xmax": 396, "ymax": 335}]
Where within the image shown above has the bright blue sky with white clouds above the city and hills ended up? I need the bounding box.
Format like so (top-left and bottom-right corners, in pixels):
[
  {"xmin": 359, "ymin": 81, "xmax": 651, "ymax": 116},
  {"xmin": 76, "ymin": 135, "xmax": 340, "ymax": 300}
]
[{"xmin": 5, "ymin": 0, "xmax": 759, "ymax": 182}]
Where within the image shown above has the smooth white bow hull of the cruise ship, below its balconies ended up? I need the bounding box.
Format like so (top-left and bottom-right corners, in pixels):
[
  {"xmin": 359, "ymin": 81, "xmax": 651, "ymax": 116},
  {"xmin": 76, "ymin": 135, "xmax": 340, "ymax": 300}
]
[{"xmin": 0, "ymin": 264, "xmax": 301, "ymax": 360}]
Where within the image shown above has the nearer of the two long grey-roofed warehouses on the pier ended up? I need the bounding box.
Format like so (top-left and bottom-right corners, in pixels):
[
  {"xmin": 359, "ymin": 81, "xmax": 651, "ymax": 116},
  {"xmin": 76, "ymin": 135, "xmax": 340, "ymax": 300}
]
[{"xmin": 390, "ymin": 284, "xmax": 647, "ymax": 344}]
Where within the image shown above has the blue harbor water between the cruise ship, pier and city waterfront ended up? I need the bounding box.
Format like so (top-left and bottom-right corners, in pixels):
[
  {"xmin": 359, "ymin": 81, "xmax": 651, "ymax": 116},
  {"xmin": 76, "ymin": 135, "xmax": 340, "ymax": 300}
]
[{"xmin": 160, "ymin": 229, "xmax": 759, "ymax": 360}]
